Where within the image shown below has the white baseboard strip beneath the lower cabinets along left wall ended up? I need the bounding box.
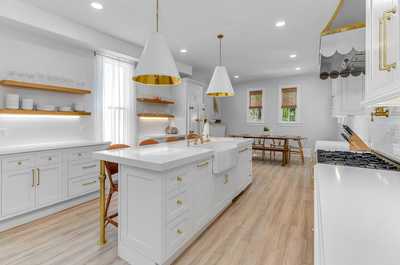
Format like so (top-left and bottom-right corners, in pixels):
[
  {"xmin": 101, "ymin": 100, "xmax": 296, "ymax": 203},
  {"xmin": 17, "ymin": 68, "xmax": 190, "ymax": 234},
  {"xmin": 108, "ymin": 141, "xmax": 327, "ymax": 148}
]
[{"xmin": 0, "ymin": 192, "xmax": 99, "ymax": 232}]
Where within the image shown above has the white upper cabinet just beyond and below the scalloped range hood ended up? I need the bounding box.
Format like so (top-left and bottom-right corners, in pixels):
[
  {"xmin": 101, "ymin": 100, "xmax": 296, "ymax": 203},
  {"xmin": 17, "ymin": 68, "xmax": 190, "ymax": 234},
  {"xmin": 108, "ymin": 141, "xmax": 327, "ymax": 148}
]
[{"xmin": 332, "ymin": 75, "xmax": 365, "ymax": 117}]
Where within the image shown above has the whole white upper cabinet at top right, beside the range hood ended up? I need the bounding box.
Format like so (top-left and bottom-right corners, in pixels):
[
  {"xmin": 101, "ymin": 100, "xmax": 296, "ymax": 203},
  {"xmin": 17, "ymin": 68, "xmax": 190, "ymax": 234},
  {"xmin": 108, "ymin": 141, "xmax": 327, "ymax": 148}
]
[{"xmin": 363, "ymin": 0, "xmax": 400, "ymax": 106}]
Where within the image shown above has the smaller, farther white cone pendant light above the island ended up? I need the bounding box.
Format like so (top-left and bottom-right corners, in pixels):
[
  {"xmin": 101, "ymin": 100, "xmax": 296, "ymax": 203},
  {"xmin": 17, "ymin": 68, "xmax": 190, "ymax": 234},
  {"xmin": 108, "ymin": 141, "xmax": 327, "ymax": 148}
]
[{"xmin": 207, "ymin": 34, "xmax": 235, "ymax": 97}]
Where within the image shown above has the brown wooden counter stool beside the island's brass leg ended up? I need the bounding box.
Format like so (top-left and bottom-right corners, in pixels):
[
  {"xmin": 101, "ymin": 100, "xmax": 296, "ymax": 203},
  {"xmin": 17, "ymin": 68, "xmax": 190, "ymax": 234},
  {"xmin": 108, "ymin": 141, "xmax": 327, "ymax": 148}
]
[{"xmin": 104, "ymin": 144, "xmax": 130, "ymax": 227}]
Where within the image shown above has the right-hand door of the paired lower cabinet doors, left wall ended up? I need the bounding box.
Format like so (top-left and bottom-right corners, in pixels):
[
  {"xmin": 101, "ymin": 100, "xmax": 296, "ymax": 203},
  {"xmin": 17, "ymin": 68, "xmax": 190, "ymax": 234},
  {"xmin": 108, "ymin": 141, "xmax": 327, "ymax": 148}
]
[{"xmin": 36, "ymin": 165, "xmax": 61, "ymax": 207}]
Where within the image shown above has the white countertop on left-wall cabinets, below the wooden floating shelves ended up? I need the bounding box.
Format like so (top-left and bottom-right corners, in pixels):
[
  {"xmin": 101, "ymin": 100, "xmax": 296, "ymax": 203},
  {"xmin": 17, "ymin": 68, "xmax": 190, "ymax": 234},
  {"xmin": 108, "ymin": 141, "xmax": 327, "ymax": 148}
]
[{"xmin": 0, "ymin": 141, "xmax": 110, "ymax": 155}]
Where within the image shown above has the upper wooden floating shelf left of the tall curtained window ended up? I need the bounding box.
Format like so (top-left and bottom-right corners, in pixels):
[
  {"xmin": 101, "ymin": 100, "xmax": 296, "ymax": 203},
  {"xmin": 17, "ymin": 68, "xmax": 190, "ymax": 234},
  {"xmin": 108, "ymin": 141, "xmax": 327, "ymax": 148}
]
[{"xmin": 0, "ymin": 80, "xmax": 92, "ymax": 95}]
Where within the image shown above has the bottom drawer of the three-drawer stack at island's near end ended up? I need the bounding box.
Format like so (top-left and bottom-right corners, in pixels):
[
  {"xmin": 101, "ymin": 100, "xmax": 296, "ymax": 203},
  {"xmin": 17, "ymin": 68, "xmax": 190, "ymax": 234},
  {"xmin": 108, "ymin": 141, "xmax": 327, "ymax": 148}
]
[{"xmin": 167, "ymin": 214, "xmax": 190, "ymax": 253}]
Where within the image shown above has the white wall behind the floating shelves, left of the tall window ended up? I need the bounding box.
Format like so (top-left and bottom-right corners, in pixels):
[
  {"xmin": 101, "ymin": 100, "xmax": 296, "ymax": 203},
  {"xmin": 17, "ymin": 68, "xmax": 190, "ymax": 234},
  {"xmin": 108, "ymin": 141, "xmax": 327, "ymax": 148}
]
[{"xmin": 0, "ymin": 20, "xmax": 94, "ymax": 146}]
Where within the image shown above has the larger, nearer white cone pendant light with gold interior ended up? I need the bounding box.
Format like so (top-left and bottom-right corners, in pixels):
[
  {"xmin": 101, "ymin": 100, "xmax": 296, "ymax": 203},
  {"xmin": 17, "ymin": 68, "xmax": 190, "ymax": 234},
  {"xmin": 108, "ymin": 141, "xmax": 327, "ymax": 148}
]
[{"xmin": 133, "ymin": 0, "xmax": 182, "ymax": 86}]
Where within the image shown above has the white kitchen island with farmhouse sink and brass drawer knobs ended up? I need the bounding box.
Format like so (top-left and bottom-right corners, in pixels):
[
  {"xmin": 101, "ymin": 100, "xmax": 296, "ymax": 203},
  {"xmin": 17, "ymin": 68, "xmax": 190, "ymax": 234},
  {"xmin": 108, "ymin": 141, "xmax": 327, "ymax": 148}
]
[{"xmin": 94, "ymin": 138, "xmax": 252, "ymax": 265}]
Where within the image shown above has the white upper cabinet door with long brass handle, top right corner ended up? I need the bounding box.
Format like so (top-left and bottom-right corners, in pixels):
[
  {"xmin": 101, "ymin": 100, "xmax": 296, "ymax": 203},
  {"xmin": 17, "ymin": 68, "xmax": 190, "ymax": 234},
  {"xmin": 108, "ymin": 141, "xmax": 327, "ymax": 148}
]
[{"xmin": 366, "ymin": 0, "xmax": 399, "ymax": 98}]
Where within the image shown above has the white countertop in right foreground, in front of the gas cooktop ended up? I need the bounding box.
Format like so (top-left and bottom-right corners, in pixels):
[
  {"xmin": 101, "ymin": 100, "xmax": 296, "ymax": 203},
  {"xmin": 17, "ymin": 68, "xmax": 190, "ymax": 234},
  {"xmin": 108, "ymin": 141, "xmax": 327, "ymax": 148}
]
[{"xmin": 315, "ymin": 164, "xmax": 400, "ymax": 265}]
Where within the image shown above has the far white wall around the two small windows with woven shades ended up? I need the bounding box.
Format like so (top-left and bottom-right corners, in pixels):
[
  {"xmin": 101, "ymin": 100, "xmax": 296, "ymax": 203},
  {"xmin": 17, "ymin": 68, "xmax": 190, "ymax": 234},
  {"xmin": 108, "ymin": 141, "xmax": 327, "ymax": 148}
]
[{"xmin": 221, "ymin": 74, "xmax": 337, "ymax": 152}]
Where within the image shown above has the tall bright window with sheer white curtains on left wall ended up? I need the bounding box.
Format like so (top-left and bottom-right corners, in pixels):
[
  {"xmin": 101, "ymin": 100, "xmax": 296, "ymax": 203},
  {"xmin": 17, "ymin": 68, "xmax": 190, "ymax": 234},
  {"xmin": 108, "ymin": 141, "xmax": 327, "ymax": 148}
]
[{"xmin": 97, "ymin": 55, "xmax": 136, "ymax": 144}]
